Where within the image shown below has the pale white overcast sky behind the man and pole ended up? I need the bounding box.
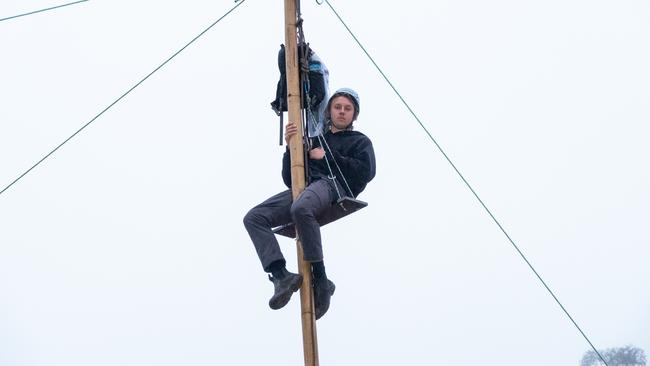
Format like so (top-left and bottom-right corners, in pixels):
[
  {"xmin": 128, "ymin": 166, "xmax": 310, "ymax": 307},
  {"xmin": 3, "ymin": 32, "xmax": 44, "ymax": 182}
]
[{"xmin": 0, "ymin": 0, "xmax": 650, "ymax": 366}]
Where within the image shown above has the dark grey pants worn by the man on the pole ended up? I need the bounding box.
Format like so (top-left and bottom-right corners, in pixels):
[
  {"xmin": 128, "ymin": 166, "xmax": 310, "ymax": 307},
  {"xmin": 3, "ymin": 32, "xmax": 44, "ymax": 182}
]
[{"xmin": 244, "ymin": 179, "xmax": 337, "ymax": 272}]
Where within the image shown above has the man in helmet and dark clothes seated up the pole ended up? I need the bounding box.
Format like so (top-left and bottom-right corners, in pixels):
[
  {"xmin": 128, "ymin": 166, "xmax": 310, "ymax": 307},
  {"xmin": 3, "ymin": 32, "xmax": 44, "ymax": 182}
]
[{"xmin": 244, "ymin": 88, "xmax": 375, "ymax": 319}]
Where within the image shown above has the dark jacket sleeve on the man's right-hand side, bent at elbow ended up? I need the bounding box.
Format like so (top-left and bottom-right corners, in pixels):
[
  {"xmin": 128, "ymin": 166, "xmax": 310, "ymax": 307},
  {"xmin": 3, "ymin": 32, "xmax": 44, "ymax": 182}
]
[{"xmin": 332, "ymin": 136, "xmax": 375, "ymax": 186}]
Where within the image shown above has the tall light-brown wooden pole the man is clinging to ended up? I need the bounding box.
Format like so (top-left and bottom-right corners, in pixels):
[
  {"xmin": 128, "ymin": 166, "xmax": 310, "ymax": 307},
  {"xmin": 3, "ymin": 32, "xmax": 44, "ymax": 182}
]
[{"xmin": 284, "ymin": 0, "xmax": 318, "ymax": 366}]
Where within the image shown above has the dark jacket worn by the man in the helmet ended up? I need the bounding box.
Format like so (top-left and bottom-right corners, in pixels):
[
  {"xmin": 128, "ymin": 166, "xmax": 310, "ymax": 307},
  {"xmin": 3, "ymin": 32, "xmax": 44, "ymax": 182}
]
[{"xmin": 282, "ymin": 131, "xmax": 375, "ymax": 197}]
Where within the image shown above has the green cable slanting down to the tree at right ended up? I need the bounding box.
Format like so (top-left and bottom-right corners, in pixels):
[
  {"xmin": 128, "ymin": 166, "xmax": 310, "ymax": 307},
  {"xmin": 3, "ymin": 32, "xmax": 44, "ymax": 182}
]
[{"xmin": 317, "ymin": 0, "xmax": 608, "ymax": 366}]
